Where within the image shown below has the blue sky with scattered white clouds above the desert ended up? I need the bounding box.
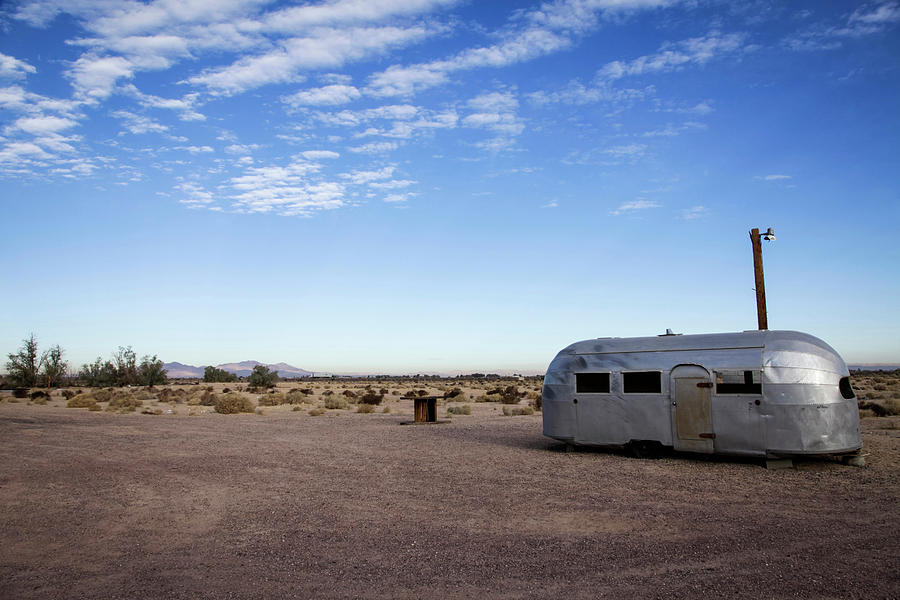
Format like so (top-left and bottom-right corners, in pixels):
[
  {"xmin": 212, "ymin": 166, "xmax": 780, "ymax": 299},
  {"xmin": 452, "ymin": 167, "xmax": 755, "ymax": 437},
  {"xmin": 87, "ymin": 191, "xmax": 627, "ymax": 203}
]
[{"xmin": 0, "ymin": 0, "xmax": 900, "ymax": 374}]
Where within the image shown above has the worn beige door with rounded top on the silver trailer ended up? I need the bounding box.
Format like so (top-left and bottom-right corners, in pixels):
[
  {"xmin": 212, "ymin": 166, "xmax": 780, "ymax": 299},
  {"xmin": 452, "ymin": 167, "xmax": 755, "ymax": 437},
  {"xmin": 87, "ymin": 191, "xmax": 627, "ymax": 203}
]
[{"xmin": 670, "ymin": 365, "xmax": 716, "ymax": 452}]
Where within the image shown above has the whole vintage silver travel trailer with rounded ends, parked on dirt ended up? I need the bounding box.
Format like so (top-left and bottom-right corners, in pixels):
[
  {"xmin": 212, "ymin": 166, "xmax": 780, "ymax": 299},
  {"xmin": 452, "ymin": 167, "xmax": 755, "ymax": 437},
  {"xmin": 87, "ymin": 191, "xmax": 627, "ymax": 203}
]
[{"xmin": 542, "ymin": 331, "xmax": 862, "ymax": 458}]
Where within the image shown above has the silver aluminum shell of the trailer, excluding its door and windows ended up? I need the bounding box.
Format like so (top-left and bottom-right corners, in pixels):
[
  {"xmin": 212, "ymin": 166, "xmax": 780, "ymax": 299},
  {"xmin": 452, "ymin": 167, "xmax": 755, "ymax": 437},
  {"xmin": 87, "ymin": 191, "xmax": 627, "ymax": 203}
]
[{"xmin": 543, "ymin": 331, "xmax": 862, "ymax": 454}]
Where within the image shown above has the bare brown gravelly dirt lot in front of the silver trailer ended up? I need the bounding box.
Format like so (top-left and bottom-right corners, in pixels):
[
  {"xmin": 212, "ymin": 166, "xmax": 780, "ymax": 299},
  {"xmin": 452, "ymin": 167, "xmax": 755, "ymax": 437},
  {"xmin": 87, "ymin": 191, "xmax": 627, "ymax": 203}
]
[{"xmin": 0, "ymin": 400, "xmax": 900, "ymax": 598}]
